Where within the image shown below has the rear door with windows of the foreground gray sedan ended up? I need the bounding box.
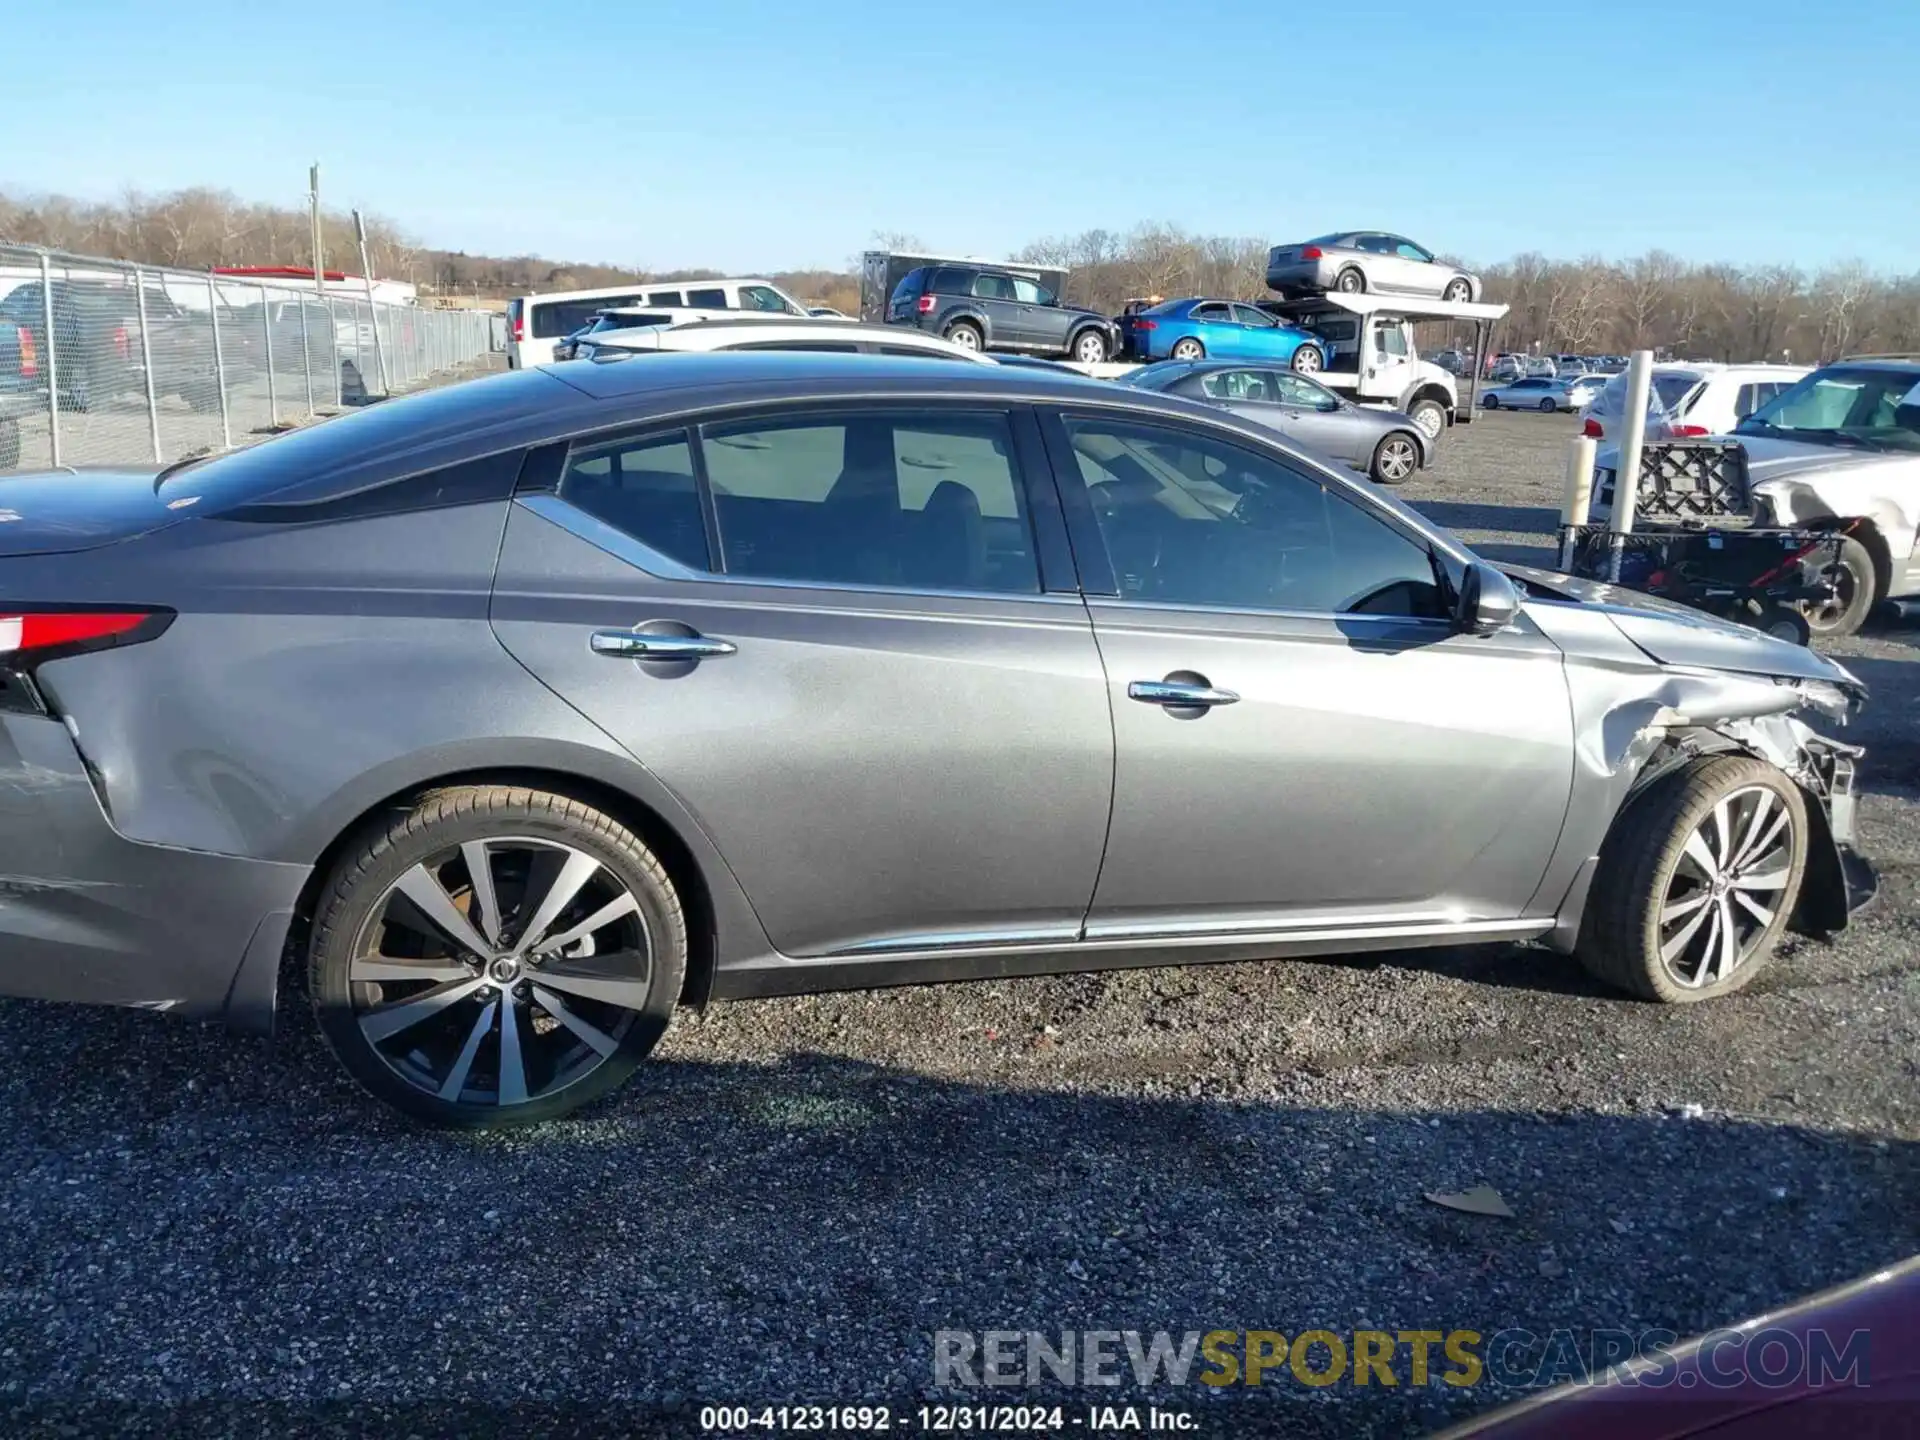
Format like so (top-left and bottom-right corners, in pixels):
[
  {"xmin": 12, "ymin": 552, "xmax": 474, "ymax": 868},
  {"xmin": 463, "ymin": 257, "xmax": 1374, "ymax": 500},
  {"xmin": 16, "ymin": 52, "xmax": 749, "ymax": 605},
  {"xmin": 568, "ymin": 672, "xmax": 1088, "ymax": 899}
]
[{"xmin": 492, "ymin": 403, "xmax": 1112, "ymax": 958}]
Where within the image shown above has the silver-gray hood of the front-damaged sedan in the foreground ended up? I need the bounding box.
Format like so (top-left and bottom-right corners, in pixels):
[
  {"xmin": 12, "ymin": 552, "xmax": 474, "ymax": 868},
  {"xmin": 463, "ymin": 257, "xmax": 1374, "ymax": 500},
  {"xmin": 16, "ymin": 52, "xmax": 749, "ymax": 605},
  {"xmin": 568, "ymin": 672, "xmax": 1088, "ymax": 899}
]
[{"xmin": 1500, "ymin": 564, "xmax": 1866, "ymax": 695}]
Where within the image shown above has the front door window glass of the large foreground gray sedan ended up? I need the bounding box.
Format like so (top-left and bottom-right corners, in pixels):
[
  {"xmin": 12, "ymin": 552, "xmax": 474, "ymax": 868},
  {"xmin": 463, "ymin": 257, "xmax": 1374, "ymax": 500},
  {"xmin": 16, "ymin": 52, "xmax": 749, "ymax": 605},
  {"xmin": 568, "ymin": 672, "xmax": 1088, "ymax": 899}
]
[{"xmin": 1068, "ymin": 420, "xmax": 1444, "ymax": 618}]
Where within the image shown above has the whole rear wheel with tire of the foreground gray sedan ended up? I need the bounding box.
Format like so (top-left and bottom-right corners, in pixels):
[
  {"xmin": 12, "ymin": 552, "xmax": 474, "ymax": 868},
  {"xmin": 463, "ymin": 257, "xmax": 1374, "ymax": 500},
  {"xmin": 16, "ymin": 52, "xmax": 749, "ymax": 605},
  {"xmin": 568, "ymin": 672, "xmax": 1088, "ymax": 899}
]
[{"xmin": 318, "ymin": 785, "xmax": 687, "ymax": 1129}]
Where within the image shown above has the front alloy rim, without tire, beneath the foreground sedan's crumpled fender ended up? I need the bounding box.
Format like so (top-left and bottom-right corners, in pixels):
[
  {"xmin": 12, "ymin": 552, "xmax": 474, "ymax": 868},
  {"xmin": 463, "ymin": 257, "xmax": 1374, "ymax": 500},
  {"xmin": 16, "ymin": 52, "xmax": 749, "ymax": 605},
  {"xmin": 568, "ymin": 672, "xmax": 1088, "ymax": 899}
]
[{"xmin": 1659, "ymin": 785, "xmax": 1799, "ymax": 989}]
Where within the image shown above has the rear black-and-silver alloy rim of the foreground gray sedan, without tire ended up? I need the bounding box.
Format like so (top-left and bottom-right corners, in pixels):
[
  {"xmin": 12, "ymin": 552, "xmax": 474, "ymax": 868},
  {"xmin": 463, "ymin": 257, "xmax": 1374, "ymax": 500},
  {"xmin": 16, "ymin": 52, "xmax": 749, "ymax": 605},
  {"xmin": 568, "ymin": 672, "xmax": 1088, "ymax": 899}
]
[{"xmin": 348, "ymin": 837, "xmax": 653, "ymax": 1108}]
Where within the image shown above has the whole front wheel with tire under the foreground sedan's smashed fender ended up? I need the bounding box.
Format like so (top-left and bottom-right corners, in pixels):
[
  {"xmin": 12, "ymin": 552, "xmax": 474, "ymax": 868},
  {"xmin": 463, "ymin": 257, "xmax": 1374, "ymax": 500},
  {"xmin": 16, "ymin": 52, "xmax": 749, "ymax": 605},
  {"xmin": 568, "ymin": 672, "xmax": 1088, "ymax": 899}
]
[{"xmin": 1576, "ymin": 755, "xmax": 1811, "ymax": 1004}]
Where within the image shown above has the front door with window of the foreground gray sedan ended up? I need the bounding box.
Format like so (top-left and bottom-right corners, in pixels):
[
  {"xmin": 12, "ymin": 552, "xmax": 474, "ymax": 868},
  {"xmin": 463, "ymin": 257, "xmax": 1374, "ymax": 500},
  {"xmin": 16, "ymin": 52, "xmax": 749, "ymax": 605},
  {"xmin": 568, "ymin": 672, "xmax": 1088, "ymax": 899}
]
[{"xmin": 1048, "ymin": 411, "xmax": 1574, "ymax": 943}]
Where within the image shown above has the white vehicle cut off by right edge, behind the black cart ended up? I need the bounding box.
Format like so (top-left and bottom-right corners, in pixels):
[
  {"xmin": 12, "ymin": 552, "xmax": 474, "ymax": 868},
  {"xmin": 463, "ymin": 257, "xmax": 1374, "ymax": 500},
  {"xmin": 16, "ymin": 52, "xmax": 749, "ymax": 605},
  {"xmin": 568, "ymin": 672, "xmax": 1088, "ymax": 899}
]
[{"xmin": 1588, "ymin": 357, "xmax": 1920, "ymax": 636}]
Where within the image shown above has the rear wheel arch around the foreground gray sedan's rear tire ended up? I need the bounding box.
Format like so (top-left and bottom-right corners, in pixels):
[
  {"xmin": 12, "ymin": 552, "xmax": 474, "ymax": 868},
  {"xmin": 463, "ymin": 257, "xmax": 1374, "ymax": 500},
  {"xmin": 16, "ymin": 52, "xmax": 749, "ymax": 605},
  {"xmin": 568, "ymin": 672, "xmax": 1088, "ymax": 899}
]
[{"xmin": 266, "ymin": 743, "xmax": 770, "ymax": 1029}]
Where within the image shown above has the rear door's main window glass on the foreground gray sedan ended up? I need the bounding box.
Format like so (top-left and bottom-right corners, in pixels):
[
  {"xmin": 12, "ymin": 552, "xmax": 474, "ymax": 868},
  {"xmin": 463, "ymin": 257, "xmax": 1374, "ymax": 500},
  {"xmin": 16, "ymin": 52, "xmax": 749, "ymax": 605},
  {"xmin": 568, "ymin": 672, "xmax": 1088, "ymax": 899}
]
[{"xmin": 703, "ymin": 413, "xmax": 1041, "ymax": 593}]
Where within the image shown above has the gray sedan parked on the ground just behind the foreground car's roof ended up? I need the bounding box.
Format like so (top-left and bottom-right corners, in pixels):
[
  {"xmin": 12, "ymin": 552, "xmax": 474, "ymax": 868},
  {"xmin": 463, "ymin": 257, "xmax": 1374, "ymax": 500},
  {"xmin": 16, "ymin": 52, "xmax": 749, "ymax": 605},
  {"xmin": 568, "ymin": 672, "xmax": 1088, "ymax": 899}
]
[{"xmin": 1125, "ymin": 361, "xmax": 1434, "ymax": 486}]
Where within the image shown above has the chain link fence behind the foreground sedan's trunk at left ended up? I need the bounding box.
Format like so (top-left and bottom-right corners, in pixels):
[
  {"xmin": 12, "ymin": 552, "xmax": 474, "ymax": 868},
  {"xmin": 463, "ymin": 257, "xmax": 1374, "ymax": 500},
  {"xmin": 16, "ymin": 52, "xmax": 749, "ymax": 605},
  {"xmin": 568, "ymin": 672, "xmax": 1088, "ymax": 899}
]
[{"xmin": 0, "ymin": 244, "xmax": 497, "ymax": 470}]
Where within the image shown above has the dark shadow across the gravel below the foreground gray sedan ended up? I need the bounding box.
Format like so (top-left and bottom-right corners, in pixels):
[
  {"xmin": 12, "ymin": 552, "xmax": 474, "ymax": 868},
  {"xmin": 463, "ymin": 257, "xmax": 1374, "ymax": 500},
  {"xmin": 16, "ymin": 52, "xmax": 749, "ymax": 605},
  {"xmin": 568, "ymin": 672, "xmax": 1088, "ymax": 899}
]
[{"xmin": 0, "ymin": 1002, "xmax": 1920, "ymax": 1436}]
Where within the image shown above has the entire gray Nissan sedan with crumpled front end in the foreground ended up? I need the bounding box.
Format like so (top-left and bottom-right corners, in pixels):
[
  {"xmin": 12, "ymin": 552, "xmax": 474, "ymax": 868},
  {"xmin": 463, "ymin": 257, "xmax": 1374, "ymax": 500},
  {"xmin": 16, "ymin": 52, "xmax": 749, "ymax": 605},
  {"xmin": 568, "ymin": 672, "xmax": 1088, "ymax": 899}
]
[{"xmin": 0, "ymin": 351, "xmax": 1870, "ymax": 1125}]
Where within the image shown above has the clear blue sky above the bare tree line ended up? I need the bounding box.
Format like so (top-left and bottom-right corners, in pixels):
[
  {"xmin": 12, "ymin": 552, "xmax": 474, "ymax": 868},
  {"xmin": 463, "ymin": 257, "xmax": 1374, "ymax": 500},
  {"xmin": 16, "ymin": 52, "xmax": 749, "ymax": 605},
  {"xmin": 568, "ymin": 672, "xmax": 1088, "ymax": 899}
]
[{"xmin": 0, "ymin": 0, "xmax": 1920, "ymax": 273}]
